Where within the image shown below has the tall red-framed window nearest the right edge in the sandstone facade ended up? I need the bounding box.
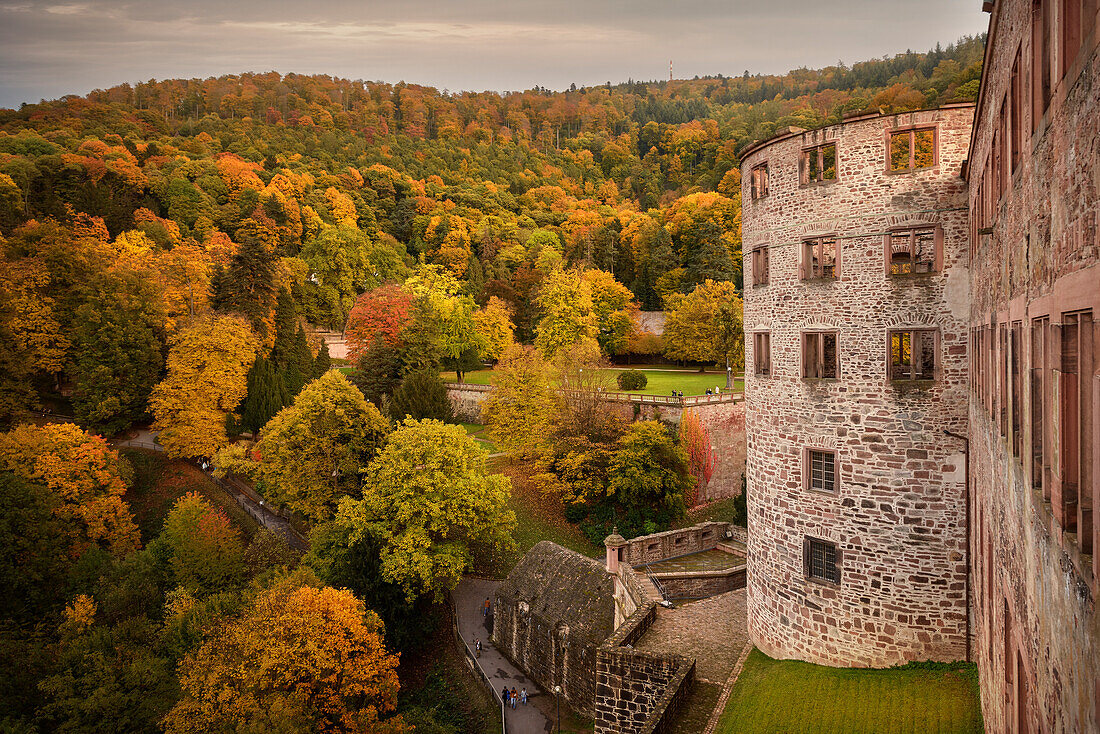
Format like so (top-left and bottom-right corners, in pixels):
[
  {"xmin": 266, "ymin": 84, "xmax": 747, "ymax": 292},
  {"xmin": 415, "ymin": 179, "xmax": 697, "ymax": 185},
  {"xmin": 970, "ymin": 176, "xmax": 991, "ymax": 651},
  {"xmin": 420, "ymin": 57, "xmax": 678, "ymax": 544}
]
[{"xmin": 1052, "ymin": 310, "xmax": 1096, "ymax": 545}]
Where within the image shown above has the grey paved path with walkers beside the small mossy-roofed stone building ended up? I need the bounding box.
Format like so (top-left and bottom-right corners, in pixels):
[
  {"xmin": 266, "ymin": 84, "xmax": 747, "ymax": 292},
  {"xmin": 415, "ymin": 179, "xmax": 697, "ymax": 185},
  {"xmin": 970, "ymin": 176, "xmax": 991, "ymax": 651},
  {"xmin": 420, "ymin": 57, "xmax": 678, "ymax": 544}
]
[{"xmin": 451, "ymin": 579, "xmax": 553, "ymax": 734}]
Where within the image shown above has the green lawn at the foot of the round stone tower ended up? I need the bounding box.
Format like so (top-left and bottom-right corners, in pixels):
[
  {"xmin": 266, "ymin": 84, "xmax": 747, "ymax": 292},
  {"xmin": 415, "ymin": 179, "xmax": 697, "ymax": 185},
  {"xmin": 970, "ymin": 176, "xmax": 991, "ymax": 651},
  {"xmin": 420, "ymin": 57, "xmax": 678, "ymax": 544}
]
[{"xmin": 717, "ymin": 649, "xmax": 982, "ymax": 734}]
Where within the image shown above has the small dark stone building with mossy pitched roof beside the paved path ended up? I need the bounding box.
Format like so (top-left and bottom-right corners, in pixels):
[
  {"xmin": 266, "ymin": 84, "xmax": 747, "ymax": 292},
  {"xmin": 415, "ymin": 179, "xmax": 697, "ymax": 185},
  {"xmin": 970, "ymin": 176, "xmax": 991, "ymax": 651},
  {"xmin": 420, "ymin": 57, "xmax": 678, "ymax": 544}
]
[{"xmin": 493, "ymin": 540, "xmax": 615, "ymax": 716}]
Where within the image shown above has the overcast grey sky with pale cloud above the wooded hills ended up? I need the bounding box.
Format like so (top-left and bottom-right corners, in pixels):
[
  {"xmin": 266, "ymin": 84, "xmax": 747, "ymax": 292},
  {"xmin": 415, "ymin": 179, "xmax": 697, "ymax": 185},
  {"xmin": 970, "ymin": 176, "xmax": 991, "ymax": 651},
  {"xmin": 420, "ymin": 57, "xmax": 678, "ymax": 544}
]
[{"xmin": 0, "ymin": 0, "xmax": 988, "ymax": 107}]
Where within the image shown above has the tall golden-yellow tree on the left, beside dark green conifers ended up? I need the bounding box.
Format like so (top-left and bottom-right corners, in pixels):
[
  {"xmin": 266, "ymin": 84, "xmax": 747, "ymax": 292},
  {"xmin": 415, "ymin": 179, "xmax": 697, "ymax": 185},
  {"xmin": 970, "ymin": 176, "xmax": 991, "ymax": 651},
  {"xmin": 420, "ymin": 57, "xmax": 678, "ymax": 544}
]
[{"xmin": 149, "ymin": 316, "xmax": 257, "ymax": 457}]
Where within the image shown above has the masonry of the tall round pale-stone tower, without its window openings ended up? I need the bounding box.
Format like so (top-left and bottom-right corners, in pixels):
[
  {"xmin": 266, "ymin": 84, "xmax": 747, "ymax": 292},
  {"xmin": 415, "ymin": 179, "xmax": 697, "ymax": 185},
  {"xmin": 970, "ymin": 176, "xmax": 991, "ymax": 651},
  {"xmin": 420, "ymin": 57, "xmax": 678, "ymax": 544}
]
[{"xmin": 741, "ymin": 106, "xmax": 974, "ymax": 667}]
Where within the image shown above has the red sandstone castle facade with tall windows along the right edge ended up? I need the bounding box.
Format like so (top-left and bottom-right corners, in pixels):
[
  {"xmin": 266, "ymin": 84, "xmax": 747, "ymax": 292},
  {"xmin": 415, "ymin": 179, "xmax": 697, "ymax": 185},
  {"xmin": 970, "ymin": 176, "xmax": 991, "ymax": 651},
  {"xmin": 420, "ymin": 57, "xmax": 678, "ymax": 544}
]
[{"xmin": 968, "ymin": 0, "xmax": 1100, "ymax": 733}]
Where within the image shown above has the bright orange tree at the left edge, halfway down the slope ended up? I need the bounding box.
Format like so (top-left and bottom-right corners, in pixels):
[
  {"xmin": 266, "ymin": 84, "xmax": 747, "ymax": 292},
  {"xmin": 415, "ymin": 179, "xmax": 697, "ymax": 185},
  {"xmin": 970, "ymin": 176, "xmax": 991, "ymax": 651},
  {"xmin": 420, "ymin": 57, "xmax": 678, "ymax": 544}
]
[{"xmin": 0, "ymin": 424, "xmax": 140, "ymax": 558}]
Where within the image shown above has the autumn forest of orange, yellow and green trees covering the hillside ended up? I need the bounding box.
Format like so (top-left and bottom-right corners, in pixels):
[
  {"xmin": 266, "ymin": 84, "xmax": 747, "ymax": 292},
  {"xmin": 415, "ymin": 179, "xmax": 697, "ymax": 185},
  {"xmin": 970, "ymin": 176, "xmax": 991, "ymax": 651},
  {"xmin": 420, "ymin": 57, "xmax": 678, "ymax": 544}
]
[{"xmin": 0, "ymin": 37, "xmax": 985, "ymax": 734}]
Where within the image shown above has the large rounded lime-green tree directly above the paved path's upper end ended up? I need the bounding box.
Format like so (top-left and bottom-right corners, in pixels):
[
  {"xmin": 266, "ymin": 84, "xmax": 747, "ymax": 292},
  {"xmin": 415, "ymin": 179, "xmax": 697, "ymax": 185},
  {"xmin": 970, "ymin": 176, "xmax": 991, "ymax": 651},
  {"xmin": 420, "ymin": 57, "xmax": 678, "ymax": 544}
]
[{"xmin": 336, "ymin": 419, "xmax": 516, "ymax": 601}]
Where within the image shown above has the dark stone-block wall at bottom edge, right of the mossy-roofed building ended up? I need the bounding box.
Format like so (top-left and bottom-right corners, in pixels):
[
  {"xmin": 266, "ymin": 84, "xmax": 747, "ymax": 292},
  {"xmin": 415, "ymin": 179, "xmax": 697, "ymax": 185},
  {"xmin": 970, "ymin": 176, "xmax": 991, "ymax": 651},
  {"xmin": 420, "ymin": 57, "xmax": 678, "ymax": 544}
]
[{"xmin": 595, "ymin": 602, "xmax": 695, "ymax": 734}]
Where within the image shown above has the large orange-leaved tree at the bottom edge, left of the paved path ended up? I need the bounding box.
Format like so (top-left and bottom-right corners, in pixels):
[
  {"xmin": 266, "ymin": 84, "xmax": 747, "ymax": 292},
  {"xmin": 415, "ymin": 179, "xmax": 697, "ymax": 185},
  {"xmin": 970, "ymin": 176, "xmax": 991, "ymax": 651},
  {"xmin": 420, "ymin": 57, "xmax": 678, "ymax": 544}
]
[{"xmin": 164, "ymin": 577, "xmax": 409, "ymax": 734}]
